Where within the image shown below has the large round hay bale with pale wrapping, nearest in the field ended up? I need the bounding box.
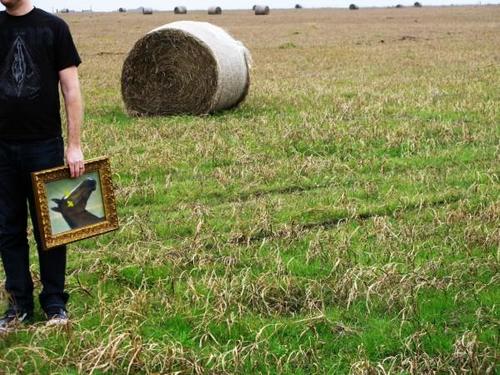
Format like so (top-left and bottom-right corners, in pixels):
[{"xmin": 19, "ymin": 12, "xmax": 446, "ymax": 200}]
[{"xmin": 121, "ymin": 21, "xmax": 251, "ymax": 116}]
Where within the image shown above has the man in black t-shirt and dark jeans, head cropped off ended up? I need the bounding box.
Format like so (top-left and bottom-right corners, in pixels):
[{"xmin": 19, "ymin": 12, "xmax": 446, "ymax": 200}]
[{"xmin": 0, "ymin": 0, "xmax": 84, "ymax": 333}]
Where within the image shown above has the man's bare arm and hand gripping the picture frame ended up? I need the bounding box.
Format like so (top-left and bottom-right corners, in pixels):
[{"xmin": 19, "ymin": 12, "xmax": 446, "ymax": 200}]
[{"xmin": 59, "ymin": 66, "xmax": 85, "ymax": 178}]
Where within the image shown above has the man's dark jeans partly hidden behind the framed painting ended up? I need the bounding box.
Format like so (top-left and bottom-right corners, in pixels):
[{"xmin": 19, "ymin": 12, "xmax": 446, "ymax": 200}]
[{"xmin": 0, "ymin": 137, "xmax": 69, "ymax": 311}]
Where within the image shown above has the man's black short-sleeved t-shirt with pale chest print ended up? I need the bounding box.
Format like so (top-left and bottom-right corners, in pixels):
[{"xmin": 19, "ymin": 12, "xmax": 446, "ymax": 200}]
[{"xmin": 0, "ymin": 8, "xmax": 81, "ymax": 140}]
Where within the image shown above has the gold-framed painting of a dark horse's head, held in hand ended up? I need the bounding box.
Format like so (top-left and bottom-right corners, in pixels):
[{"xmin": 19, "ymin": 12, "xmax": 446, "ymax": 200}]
[{"xmin": 31, "ymin": 157, "xmax": 118, "ymax": 250}]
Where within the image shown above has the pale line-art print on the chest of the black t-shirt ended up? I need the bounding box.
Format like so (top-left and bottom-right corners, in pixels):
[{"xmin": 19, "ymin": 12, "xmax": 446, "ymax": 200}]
[{"xmin": 0, "ymin": 35, "xmax": 41, "ymax": 99}]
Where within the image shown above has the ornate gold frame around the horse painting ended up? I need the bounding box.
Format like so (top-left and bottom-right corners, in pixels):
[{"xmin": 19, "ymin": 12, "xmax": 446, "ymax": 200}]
[{"xmin": 31, "ymin": 157, "xmax": 118, "ymax": 250}]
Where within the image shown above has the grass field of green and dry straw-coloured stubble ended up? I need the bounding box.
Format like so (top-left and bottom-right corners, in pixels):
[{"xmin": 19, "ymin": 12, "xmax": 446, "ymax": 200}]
[{"xmin": 0, "ymin": 6, "xmax": 500, "ymax": 374}]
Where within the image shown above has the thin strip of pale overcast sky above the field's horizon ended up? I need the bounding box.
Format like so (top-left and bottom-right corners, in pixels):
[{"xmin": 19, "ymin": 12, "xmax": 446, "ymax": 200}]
[{"xmin": 0, "ymin": 0, "xmax": 500, "ymax": 12}]
